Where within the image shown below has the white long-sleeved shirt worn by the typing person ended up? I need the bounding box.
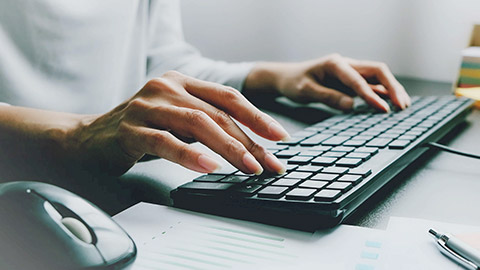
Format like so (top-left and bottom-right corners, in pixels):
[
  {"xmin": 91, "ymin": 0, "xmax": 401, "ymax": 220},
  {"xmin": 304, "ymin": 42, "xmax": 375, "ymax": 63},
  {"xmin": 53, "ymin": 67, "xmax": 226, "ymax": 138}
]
[{"xmin": 0, "ymin": 0, "xmax": 253, "ymax": 113}]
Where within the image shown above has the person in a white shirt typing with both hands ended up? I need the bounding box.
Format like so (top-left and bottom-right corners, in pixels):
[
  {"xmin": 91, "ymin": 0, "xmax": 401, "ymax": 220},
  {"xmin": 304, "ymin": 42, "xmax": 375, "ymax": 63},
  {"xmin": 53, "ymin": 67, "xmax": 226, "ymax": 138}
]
[{"xmin": 0, "ymin": 0, "xmax": 410, "ymax": 180}]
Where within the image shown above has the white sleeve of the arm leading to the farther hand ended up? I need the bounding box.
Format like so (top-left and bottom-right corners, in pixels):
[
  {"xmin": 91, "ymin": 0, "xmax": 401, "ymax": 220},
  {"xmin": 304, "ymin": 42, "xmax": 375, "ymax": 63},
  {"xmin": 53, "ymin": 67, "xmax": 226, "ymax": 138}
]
[{"xmin": 147, "ymin": 0, "xmax": 255, "ymax": 90}]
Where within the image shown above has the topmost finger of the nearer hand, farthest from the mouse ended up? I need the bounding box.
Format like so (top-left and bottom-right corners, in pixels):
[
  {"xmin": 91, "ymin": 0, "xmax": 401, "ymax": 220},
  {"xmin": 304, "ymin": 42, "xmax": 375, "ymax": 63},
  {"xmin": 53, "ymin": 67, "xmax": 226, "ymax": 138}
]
[{"xmin": 177, "ymin": 74, "xmax": 290, "ymax": 141}]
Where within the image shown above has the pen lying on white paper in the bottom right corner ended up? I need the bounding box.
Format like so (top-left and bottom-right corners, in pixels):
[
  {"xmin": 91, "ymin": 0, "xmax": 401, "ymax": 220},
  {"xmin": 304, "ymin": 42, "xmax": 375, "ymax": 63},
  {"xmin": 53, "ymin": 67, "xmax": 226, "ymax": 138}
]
[{"xmin": 428, "ymin": 229, "xmax": 480, "ymax": 270}]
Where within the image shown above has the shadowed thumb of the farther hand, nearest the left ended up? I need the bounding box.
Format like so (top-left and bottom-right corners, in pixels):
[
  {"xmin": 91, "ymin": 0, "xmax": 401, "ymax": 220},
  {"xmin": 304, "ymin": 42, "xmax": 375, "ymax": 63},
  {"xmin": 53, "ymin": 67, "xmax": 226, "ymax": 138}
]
[{"xmin": 302, "ymin": 80, "xmax": 353, "ymax": 110}]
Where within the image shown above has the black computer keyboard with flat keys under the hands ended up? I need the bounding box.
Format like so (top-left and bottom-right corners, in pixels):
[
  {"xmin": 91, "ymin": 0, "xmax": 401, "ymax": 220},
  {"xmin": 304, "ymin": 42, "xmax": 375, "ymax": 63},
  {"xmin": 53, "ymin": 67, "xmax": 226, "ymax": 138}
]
[{"xmin": 171, "ymin": 96, "xmax": 473, "ymax": 230}]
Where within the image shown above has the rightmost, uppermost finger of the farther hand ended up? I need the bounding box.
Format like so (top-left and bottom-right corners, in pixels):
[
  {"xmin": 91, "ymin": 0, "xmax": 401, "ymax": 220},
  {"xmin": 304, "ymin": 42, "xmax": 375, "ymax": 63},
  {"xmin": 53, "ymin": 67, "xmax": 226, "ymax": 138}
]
[{"xmin": 351, "ymin": 60, "xmax": 410, "ymax": 109}]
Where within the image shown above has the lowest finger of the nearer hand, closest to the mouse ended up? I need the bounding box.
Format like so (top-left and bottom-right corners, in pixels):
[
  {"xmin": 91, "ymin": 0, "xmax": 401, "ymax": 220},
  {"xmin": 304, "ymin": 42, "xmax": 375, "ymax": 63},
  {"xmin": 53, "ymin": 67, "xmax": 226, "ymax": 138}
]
[{"xmin": 124, "ymin": 126, "xmax": 220, "ymax": 173}]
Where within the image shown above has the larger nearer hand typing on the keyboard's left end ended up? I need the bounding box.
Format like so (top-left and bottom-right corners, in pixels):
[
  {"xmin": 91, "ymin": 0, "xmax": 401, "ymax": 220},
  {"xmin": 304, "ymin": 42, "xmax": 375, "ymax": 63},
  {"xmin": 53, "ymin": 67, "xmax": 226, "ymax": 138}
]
[{"xmin": 73, "ymin": 71, "xmax": 288, "ymax": 175}]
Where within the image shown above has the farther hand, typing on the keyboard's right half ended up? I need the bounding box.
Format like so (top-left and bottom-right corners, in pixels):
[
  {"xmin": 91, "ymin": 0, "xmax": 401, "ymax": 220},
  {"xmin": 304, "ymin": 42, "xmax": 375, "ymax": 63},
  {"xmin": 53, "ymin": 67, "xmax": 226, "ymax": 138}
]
[{"xmin": 245, "ymin": 54, "xmax": 411, "ymax": 112}]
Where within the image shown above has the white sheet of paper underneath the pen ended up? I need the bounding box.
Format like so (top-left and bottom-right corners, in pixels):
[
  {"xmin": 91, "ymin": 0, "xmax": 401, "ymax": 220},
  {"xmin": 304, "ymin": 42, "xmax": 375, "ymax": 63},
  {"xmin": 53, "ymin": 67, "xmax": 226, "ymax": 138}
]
[{"xmin": 385, "ymin": 217, "xmax": 480, "ymax": 270}]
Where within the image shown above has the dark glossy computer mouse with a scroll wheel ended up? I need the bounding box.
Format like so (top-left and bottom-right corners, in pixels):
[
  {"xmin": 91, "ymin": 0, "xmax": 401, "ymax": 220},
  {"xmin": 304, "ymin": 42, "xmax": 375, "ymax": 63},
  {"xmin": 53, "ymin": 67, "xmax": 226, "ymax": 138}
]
[{"xmin": 0, "ymin": 182, "xmax": 137, "ymax": 269}]
